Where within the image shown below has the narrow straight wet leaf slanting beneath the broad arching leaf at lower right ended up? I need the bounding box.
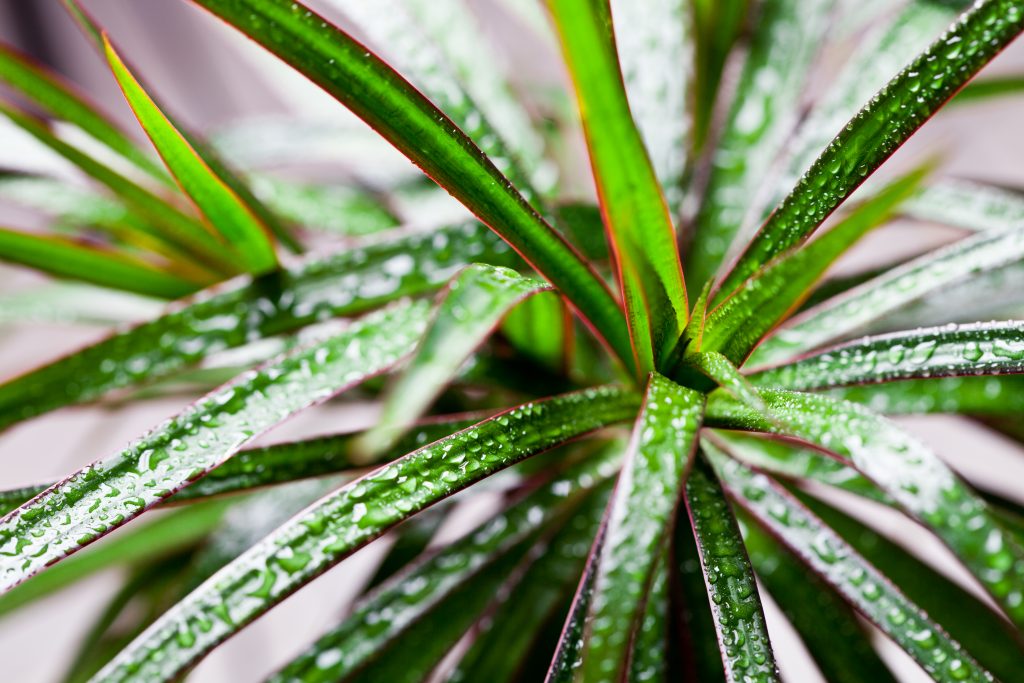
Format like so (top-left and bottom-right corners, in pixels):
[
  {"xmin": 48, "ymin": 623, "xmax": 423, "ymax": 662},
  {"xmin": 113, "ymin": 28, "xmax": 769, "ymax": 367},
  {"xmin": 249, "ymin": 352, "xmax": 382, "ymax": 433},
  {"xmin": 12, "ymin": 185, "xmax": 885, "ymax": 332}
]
[{"xmin": 713, "ymin": 450, "xmax": 993, "ymax": 683}]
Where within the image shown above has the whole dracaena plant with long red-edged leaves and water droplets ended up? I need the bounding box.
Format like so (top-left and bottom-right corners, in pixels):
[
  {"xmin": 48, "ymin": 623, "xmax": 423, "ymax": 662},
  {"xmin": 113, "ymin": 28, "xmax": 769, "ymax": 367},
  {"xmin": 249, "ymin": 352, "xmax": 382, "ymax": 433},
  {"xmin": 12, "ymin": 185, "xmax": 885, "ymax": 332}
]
[{"xmin": 0, "ymin": 0, "xmax": 1024, "ymax": 682}]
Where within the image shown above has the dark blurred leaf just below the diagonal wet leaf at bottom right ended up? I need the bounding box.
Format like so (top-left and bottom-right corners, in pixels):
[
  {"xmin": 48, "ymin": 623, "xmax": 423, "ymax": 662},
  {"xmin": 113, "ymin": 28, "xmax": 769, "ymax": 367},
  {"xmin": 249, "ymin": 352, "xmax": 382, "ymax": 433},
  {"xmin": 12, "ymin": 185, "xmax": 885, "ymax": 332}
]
[{"xmin": 739, "ymin": 515, "xmax": 897, "ymax": 683}]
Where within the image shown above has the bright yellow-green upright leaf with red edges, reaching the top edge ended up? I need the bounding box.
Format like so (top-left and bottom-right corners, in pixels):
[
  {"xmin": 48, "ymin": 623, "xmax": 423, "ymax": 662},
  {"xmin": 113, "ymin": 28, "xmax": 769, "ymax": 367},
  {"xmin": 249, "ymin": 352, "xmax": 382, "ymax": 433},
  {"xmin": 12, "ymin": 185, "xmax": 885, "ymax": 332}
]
[{"xmin": 548, "ymin": 0, "xmax": 687, "ymax": 374}]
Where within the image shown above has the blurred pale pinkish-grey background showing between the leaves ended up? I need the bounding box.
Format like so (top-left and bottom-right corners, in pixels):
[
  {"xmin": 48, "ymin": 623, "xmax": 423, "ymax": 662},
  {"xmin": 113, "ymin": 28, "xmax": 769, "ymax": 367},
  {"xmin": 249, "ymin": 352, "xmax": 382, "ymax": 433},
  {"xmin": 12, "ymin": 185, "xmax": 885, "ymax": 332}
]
[{"xmin": 0, "ymin": 0, "xmax": 1024, "ymax": 683}]
